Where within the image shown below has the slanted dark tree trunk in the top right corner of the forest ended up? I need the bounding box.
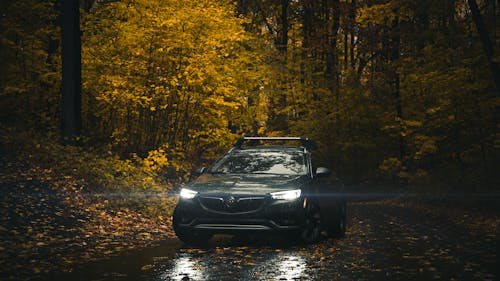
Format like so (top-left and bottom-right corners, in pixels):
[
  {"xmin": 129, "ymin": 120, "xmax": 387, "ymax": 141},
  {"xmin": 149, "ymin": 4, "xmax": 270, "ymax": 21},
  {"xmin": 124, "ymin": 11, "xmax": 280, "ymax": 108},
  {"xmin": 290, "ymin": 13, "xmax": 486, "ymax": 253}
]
[{"xmin": 467, "ymin": 0, "xmax": 500, "ymax": 94}]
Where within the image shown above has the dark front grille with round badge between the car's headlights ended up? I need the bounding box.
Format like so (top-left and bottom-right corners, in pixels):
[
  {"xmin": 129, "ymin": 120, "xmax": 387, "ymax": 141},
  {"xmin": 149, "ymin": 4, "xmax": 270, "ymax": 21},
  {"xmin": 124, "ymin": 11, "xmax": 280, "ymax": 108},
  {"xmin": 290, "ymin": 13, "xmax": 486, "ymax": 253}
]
[{"xmin": 199, "ymin": 196, "xmax": 265, "ymax": 213}]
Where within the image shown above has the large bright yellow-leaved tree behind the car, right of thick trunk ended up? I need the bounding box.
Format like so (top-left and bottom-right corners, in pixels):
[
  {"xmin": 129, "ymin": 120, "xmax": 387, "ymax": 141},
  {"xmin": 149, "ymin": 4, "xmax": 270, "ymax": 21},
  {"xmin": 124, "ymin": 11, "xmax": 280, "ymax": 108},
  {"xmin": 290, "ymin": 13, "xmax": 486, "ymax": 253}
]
[{"xmin": 83, "ymin": 0, "xmax": 267, "ymax": 171}]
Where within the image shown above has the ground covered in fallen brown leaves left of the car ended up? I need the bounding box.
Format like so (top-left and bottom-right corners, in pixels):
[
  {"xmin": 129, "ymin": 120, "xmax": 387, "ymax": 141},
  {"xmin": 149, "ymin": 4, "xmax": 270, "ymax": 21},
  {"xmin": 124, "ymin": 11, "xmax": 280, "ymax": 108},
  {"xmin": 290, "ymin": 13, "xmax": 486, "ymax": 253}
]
[{"xmin": 0, "ymin": 153, "xmax": 174, "ymax": 280}]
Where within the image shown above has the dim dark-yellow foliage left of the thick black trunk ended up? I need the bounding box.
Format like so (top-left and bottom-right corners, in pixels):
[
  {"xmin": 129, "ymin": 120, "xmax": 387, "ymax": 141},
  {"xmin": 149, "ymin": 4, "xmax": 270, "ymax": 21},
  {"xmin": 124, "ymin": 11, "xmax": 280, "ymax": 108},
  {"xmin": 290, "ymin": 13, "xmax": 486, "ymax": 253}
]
[{"xmin": 0, "ymin": 0, "xmax": 61, "ymax": 133}]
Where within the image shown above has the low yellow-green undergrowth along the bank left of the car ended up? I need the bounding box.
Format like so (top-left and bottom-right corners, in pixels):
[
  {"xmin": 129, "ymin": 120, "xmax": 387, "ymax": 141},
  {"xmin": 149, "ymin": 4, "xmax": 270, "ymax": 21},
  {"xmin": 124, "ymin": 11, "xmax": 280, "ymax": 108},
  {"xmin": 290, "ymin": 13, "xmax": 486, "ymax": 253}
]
[{"xmin": 0, "ymin": 128, "xmax": 177, "ymax": 218}]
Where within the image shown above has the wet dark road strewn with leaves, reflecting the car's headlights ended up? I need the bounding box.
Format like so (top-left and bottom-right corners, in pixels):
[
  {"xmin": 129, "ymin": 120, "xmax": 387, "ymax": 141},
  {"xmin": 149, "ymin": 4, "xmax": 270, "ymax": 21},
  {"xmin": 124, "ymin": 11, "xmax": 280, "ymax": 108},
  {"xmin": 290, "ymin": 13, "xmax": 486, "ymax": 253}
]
[{"xmin": 52, "ymin": 201, "xmax": 500, "ymax": 280}]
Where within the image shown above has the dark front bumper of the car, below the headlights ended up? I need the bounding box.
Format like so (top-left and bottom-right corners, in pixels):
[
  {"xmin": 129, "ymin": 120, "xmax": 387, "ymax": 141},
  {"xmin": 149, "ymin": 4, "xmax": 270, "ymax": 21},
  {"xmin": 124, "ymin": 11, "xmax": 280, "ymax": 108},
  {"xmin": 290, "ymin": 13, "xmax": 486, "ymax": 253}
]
[{"xmin": 174, "ymin": 194, "xmax": 304, "ymax": 234}]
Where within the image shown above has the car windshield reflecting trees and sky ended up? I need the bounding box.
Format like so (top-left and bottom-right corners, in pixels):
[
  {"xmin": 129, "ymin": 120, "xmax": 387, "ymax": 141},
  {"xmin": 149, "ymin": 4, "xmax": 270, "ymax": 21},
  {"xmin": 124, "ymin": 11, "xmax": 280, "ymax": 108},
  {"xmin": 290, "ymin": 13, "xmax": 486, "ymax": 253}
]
[{"xmin": 210, "ymin": 150, "xmax": 307, "ymax": 175}]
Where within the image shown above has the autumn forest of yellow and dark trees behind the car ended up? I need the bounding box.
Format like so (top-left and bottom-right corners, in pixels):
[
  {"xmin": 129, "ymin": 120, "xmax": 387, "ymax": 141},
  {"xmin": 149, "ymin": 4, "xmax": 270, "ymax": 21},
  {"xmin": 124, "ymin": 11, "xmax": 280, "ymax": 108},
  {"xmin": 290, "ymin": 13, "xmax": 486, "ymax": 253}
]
[{"xmin": 0, "ymin": 0, "xmax": 500, "ymax": 192}]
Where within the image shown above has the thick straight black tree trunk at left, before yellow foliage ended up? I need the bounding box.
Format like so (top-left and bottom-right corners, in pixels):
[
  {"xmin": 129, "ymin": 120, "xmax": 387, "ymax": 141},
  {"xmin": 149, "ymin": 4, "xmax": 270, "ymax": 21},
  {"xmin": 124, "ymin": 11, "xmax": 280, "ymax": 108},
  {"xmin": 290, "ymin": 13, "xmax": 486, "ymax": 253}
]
[{"xmin": 61, "ymin": 0, "xmax": 82, "ymax": 144}]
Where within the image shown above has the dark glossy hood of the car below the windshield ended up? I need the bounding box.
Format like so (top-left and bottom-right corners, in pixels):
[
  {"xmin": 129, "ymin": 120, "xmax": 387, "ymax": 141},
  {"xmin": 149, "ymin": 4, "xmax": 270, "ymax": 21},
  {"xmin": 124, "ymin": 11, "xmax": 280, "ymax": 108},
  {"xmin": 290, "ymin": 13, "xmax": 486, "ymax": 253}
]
[{"xmin": 186, "ymin": 173, "xmax": 310, "ymax": 195}]
